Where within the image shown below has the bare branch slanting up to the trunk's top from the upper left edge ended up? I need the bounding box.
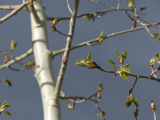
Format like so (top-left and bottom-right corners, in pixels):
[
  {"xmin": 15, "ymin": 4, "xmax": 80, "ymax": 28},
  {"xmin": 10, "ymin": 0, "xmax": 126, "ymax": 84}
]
[{"xmin": 0, "ymin": 1, "xmax": 28, "ymax": 24}]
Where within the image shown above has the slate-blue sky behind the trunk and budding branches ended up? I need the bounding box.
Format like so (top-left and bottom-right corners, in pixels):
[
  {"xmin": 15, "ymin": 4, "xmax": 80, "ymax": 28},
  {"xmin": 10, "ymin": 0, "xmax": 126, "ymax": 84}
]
[{"xmin": 0, "ymin": 0, "xmax": 160, "ymax": 120}]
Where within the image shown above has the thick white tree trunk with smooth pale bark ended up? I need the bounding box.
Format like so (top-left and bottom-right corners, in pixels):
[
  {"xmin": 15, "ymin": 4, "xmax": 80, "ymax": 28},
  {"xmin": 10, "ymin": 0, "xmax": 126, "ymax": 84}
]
[{"xmin": 30, "ymin": 0, "xmax": 61, "ymax": 120}]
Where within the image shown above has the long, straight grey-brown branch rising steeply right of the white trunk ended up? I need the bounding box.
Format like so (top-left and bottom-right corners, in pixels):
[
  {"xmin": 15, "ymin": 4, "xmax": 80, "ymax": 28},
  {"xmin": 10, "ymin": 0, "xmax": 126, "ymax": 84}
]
[{"xmin": 54, "ymin": 0, "xmax": 79, "ymax": 100}]
